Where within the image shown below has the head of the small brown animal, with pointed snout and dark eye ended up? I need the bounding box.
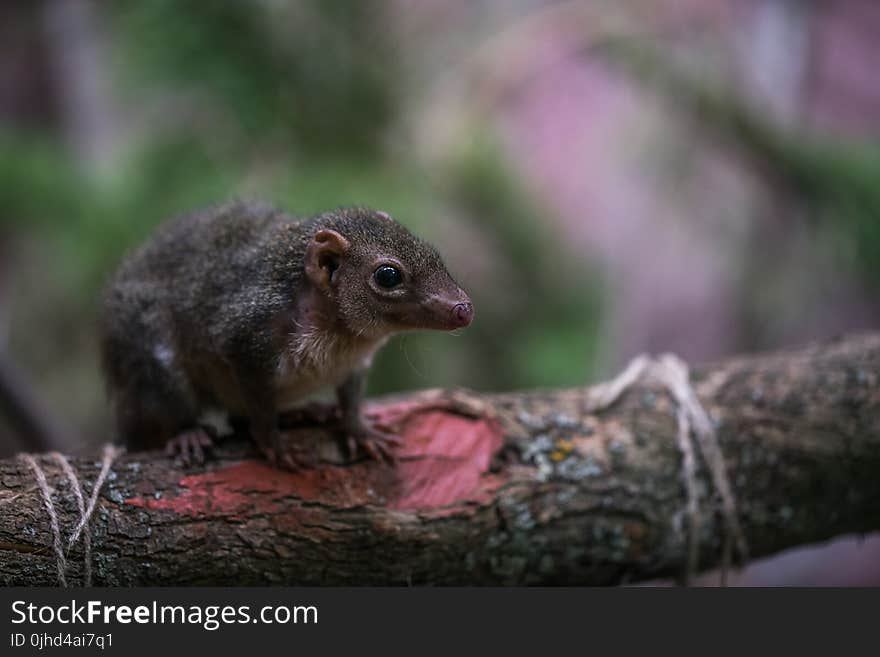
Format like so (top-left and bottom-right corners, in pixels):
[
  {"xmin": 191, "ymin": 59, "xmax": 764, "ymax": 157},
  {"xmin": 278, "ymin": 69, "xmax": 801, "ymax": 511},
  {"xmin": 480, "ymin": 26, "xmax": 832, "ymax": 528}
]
[{"xmin": 305, "ymin": 208, "xmax": 474, "ymax": 338}]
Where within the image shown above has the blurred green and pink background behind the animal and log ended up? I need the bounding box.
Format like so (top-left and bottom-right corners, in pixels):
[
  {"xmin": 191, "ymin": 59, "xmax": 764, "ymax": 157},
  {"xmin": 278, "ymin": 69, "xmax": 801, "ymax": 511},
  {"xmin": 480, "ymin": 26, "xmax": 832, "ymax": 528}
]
[{"xmin": 0, "ymin": 0, "xmax": 880, "ymax": 584}]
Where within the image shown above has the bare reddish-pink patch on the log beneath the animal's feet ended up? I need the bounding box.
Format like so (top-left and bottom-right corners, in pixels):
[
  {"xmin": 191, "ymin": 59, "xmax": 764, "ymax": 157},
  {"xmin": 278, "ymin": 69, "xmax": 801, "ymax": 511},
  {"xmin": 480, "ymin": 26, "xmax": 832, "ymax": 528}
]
[{"xmin": 127, "ymin": 405, "xmax": 503, "ymax": 518}]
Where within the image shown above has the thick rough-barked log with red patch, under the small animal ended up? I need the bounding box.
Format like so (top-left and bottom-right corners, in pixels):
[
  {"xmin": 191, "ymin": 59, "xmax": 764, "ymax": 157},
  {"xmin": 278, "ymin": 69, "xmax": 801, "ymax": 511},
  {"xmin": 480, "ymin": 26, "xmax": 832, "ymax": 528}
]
[{"xmin": 0, "ymin": 334, "xmax": 880, "ymax": 586}]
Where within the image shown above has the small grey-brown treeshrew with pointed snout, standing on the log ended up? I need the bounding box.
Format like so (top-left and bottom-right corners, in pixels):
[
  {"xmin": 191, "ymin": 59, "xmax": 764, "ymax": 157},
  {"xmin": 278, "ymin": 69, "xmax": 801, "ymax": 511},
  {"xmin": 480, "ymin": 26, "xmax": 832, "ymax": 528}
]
[{"xmin": 101, "ymin": 202, "xmax": 473, "ymax": 466}]
